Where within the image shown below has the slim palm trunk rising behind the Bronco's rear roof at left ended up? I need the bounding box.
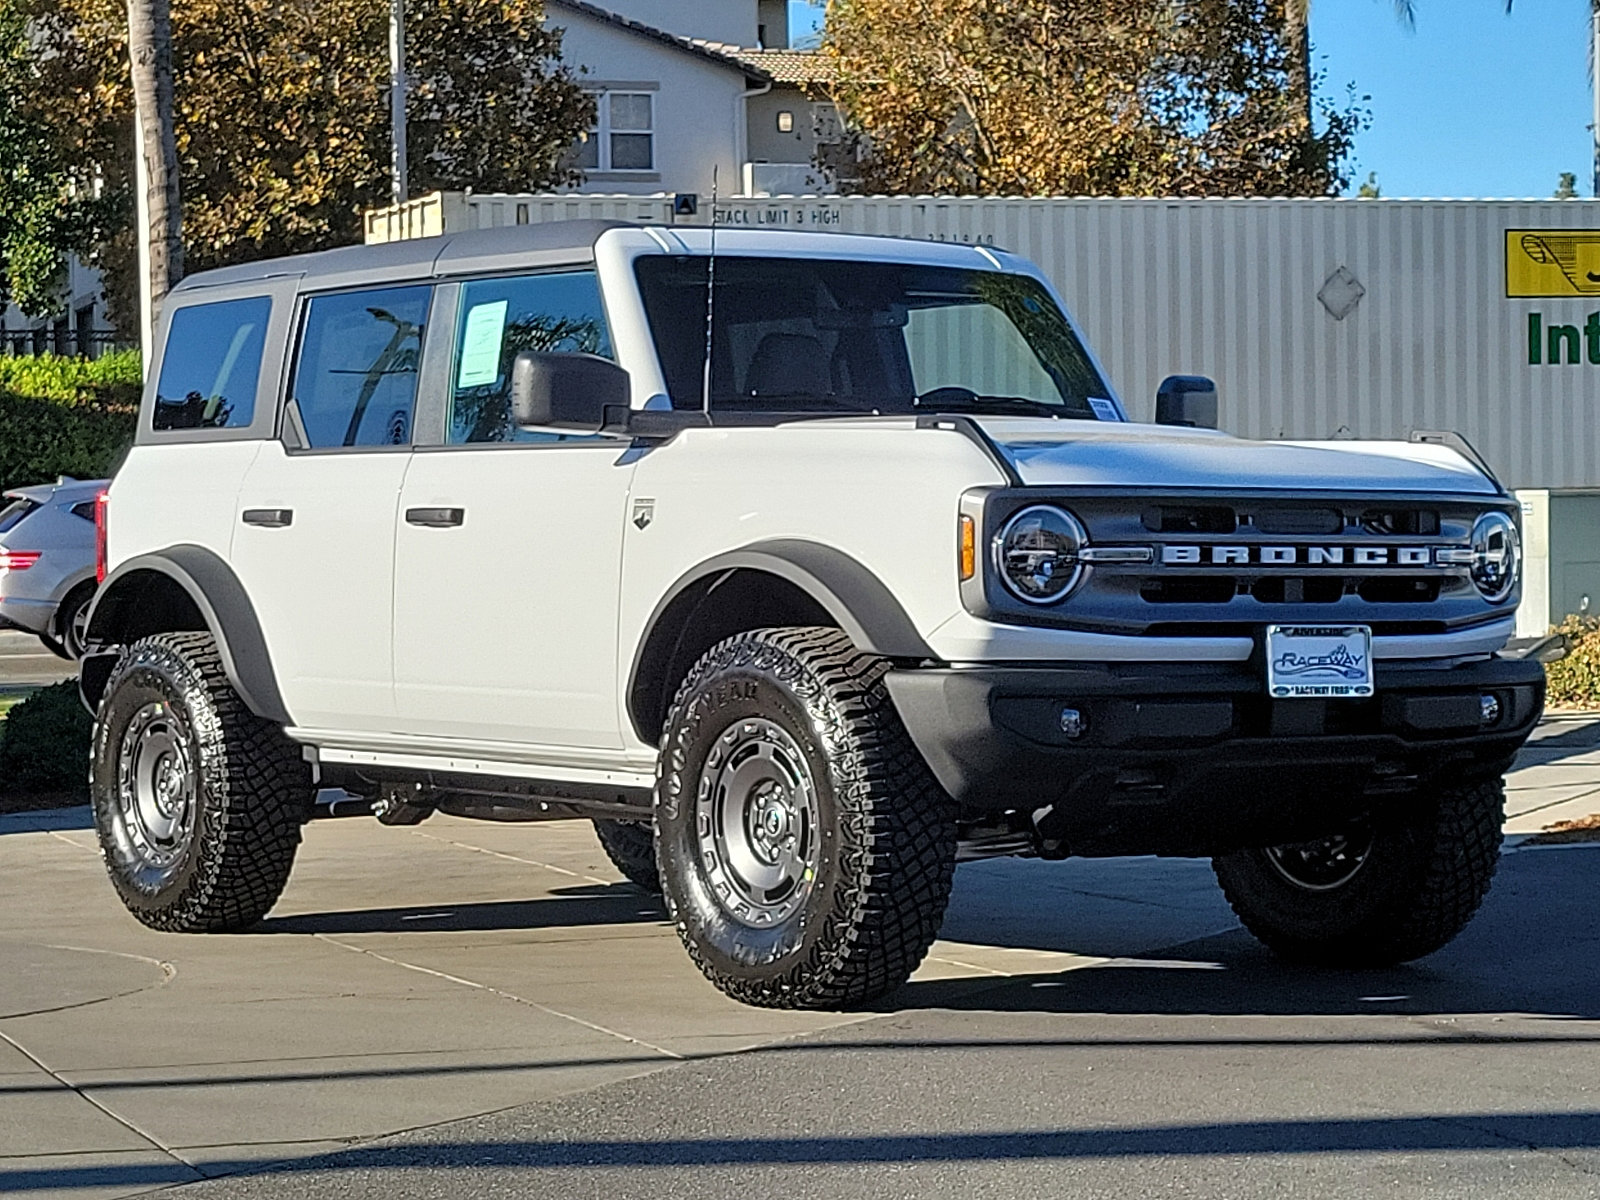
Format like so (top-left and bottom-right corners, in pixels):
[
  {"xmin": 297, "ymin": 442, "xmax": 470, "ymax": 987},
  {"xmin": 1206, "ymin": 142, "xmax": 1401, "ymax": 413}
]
[{"xmin": 128, "ymin": 0, "xmax": 184, "ymax": 345}]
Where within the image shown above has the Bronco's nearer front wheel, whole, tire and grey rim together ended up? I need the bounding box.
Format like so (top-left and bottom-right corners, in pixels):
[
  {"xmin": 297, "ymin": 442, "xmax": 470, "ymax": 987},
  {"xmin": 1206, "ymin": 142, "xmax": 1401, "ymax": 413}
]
[{"xmin": 656, "ymin": 629, "xmax": 955, "ymax": 1008}]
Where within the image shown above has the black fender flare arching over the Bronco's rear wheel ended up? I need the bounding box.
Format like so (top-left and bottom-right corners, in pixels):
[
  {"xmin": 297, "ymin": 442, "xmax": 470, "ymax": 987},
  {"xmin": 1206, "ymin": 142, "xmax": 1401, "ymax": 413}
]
[{"xmin": 78, "ymin": 546, "xmax": 293, "ymax": 725}]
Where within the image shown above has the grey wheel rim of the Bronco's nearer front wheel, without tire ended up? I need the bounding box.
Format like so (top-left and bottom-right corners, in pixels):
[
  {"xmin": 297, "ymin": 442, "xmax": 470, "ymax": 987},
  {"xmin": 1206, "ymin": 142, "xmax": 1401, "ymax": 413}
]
[{"xmin": 694, "ymin": 717, "xmax": 821, "ymax": 928}]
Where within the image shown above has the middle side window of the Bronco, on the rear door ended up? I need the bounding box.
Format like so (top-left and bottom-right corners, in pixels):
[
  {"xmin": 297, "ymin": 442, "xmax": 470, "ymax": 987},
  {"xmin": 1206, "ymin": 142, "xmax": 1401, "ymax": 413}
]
[{"xmin": 291, "ymin": 285, "xmax": 434, "ymax": 450}]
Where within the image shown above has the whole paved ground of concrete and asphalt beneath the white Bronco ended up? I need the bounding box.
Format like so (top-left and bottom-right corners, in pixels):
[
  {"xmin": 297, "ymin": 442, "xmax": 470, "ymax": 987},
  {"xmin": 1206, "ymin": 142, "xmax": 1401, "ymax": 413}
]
[{"xmin": 0, "ymin": 790, "xmax": 1600, "ymax": 1200}]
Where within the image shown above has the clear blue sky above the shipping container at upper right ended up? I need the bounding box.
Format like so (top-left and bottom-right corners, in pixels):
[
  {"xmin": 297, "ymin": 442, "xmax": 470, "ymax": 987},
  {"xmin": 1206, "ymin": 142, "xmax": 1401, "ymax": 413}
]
[{"xmin": 790, "ymin": 0, "xmax": 1592, "ymax": 197}]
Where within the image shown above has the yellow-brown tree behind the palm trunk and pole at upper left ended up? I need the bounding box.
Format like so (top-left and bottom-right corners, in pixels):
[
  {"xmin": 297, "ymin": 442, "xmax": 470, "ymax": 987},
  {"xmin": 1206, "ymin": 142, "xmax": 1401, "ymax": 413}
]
[{"xmin": 20, "ymin": 0, "xmax": 592, "ymax": 326}]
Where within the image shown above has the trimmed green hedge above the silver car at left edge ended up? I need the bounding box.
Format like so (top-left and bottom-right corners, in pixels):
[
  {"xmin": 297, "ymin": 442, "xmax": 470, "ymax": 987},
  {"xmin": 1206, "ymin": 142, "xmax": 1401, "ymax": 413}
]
[{"xmin": 0, "ymin": 350, "xmax": 139, "ymax": 488}]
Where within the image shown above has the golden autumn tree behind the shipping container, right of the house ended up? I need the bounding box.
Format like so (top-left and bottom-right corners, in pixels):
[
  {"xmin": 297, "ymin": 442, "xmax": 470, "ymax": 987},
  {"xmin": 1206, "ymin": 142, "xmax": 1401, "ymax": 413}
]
[{"xmin": 824, "ymin": 0, "xmax": 1366, "ymax": 195}]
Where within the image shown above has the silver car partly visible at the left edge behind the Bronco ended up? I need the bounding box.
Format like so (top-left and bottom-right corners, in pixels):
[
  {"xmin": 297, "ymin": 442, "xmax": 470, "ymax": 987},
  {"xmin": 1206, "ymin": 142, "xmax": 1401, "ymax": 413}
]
[{"xmin": 0, "ymin": 477, "xmax": 109, "ymax": 661}]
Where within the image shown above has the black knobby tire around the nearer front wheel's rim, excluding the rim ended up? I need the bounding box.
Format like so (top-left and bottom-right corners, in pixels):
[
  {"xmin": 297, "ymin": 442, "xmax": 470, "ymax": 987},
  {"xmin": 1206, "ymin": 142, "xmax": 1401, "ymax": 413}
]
[{"xmin": 656, "ymin": 627, "xmax": 955, "ymax": 1010}]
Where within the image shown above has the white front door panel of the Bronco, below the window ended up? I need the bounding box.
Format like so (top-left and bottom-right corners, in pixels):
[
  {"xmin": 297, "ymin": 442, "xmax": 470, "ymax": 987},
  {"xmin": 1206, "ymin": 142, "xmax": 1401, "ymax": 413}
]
[{"xmin": 394, "ymin": 440, "xmax": 634, "ymax": 749}]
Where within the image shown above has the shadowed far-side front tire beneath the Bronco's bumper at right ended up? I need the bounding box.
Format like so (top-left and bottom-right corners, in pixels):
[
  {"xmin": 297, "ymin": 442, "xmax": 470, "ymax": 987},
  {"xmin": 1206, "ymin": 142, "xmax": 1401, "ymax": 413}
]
[{"xmin": 1213, "ymin": 779, "xmax": 1506, "ymax": 968}]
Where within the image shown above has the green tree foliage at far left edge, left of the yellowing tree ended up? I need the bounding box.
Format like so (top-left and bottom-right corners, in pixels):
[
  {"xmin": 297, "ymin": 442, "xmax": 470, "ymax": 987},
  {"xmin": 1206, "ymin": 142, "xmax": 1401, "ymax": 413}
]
[{"xmin": 0, "ymin": 0, "xmax": 115, "ymax": 317}]
